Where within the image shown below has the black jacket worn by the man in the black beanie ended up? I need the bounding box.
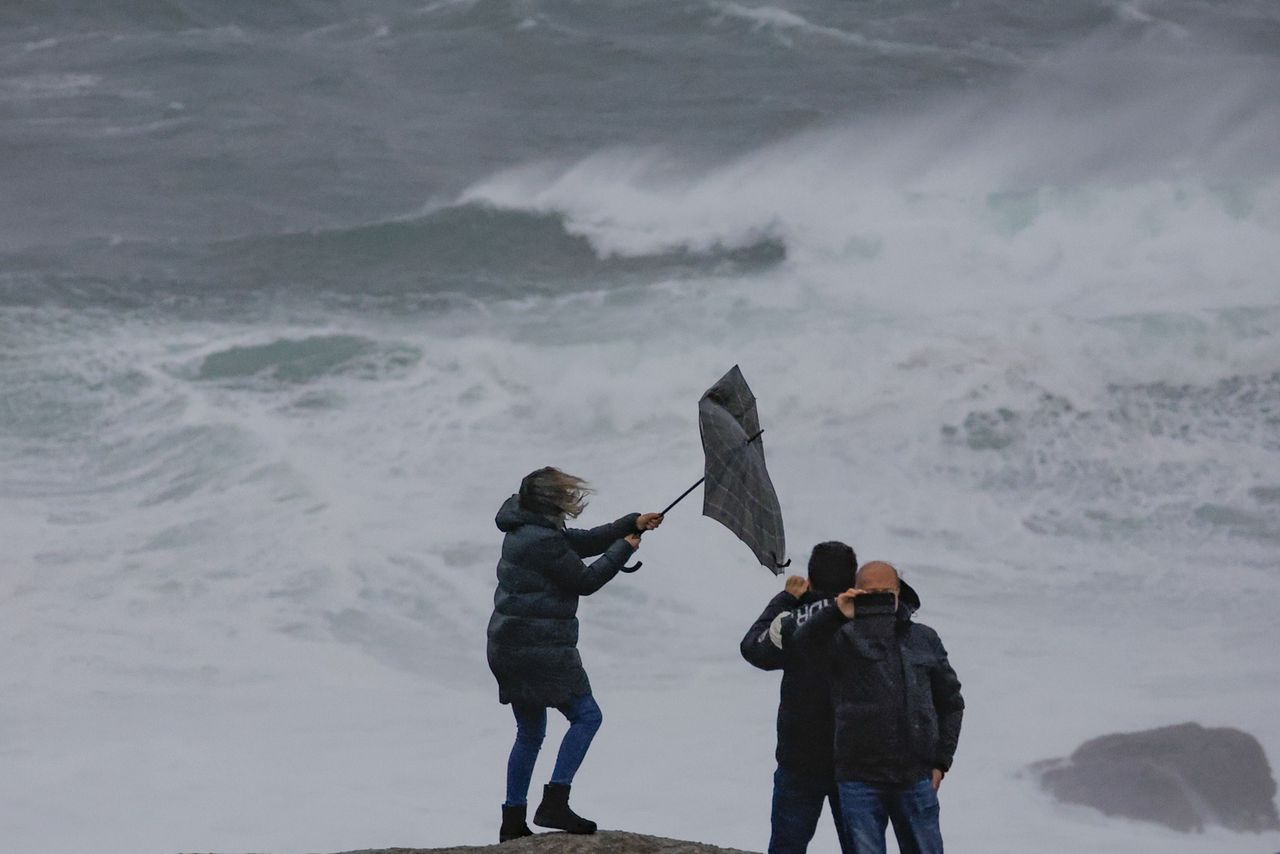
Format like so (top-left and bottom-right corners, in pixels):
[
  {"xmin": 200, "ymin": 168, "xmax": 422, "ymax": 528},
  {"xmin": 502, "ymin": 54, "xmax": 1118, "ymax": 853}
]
[{"xmin": 740, "ymin": 583, "xmax": 920, "ymax": 780}]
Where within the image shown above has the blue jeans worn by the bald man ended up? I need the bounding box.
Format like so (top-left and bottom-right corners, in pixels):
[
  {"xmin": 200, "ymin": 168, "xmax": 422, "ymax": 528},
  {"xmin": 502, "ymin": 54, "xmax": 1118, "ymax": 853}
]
[{"xmin": 840, "ymin": 780, "xmax": 942, "ymax": 854}]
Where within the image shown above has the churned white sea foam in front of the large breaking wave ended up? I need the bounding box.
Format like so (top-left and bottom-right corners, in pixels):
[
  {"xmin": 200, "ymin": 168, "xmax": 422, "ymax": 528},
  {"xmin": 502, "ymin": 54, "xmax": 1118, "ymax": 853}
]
[{"xmin": 3, "ymin": 241, "xmax": 1280, "ymax": 853}]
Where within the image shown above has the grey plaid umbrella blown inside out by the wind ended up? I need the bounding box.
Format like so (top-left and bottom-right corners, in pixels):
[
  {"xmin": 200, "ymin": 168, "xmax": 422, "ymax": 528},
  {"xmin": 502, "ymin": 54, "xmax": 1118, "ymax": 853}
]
[{"xmin": 650, "ymin": 365, "xmax": 791, "ymax": 575}]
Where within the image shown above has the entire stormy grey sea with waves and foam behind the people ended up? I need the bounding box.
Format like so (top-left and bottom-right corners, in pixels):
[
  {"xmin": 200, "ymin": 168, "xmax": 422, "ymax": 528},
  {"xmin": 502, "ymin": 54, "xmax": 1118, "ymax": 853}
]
[{"xmin": 0, "ymin": 0, "xmax": 1280, "ymax": 854}]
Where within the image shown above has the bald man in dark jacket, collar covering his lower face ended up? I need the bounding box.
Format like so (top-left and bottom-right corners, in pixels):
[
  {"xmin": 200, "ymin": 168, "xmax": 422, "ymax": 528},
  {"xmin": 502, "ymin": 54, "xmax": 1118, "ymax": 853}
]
[{"xmin": 794, "ymin": 561, "xmax": 964, "ymax": 854}]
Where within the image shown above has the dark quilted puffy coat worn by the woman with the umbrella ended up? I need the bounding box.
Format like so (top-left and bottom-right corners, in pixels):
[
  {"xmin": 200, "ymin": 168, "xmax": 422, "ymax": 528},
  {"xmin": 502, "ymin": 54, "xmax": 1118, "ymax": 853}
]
[{"xmin": 488, "ymin": 495, "xmax": 639, "ymax": 707}]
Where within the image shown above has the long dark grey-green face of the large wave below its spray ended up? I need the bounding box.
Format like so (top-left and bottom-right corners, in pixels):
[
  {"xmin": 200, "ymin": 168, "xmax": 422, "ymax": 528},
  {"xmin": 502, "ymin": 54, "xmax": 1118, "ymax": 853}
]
[{"xmin": 0, "ymin": 204, "xmax": 786, "ymax": 310}]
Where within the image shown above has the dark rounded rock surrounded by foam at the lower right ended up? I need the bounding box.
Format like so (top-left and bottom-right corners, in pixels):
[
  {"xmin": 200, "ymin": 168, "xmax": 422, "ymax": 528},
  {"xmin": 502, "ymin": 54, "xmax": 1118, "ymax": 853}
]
[{"xmin": 1030, "ymin": 723, "xmax": 1280, "ymax": 832}]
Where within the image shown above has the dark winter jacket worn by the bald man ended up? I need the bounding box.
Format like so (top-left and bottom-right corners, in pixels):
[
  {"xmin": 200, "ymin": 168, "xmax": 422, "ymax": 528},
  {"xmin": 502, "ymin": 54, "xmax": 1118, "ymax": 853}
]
[{"xmin": 792, "ymin": 604, "xmax": 964, "ymax": 785}]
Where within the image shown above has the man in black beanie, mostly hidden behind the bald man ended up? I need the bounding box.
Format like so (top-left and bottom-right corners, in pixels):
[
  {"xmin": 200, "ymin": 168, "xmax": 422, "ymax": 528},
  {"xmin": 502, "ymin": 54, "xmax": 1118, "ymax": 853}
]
[{"xmin": 741, "ymin": 542, "xmax": 858, "ymax": 854}]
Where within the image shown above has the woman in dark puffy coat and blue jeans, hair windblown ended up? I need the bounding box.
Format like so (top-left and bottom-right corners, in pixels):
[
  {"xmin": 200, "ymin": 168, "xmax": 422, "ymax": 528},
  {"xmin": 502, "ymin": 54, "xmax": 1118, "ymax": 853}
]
[{"xmin": 488, "ymin": 467, "xmax": 662, "ymax": 842}]
